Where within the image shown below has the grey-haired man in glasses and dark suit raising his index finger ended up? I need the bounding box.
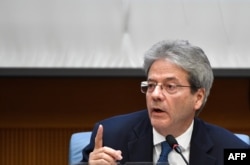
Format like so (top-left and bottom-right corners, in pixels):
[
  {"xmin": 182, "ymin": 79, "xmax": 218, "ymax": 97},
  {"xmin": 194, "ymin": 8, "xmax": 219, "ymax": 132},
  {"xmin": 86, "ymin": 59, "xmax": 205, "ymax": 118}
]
[{"xmin": 82, "ymin": 40, "xmax": 249, "ymax": 165}]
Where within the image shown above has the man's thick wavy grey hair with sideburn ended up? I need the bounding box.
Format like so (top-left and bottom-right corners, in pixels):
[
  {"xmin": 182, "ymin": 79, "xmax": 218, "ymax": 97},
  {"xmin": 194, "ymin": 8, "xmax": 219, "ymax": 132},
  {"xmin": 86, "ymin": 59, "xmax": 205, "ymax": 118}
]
[{"xmin": 143, "ymin": 40, "xmax": 214, "ymax": 114}]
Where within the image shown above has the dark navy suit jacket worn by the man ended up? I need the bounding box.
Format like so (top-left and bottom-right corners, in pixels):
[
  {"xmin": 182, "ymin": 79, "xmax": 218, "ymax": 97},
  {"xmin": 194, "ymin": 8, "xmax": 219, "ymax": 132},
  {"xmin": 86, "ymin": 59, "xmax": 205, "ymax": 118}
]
[{"xmin": 82, "ymin": 110, "xmax": 249, "ymax": 165}]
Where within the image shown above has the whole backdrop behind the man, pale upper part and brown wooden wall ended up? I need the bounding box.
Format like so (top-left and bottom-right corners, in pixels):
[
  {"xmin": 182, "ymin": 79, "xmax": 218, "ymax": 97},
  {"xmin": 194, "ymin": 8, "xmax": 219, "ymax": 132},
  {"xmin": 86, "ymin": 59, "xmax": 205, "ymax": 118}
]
[{"xmin": 0, "ymin": 0, "xmax": 250, "ymax": 165}]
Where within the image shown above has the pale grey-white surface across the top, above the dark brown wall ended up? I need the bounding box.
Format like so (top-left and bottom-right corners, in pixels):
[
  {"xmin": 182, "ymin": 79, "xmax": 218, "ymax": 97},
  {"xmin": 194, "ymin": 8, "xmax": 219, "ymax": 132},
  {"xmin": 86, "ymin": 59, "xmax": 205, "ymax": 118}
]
[{"xmin": 0, "ymin": 0, "xmax": 250, "ymax": 68}]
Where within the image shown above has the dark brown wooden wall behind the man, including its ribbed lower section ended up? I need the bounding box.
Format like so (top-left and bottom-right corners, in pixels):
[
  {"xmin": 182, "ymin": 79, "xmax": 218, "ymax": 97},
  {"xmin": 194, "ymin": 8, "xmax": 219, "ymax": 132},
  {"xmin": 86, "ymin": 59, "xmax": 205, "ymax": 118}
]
[{"xmin": 0, "ymin": 77, "xmax": 250, "ymax": 165}]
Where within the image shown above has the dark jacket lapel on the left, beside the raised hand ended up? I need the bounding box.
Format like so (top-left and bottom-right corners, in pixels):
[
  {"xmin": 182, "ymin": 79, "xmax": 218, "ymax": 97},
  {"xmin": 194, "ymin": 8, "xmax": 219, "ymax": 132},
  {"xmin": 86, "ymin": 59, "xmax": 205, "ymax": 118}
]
[{"xmin": 128, "ymin": 116, "xmax": 153, "ymax": 162}]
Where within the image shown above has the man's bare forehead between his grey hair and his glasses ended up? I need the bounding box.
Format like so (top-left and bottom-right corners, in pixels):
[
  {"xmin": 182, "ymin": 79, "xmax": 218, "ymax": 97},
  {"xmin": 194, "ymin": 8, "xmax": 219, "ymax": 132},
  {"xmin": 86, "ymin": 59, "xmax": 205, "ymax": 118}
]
[{"xmin": 148, "ymin": 59, "xmax": 188, "ymax": 82}]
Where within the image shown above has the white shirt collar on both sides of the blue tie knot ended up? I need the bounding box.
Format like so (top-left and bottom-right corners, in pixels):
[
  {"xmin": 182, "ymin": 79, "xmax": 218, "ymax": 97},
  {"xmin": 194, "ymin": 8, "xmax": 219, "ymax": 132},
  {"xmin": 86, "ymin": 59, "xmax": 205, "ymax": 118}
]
[{"xmin": 153, "ymin": 121, "xmax": 194, "ymax": 150}]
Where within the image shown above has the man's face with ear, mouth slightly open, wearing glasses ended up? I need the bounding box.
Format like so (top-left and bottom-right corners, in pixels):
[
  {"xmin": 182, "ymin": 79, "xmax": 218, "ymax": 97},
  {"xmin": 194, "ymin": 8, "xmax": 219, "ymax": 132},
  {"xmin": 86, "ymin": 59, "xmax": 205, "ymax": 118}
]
[{"xmin": 146, "ymin": 59, "xmax": 204, "ymax": 136}]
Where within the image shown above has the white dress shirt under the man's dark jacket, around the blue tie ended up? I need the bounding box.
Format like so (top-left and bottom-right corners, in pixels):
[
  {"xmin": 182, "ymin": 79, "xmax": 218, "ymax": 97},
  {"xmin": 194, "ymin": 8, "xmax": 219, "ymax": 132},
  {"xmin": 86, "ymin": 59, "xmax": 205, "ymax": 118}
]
[{"xmin": 153, "ymin": 121, "xmax": 194, "ymax": 165}]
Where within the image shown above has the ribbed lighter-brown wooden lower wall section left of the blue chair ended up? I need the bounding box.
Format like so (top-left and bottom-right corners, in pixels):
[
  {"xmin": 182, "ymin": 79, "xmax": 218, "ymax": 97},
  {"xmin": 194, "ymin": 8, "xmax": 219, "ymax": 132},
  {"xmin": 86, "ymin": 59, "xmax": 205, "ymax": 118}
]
[{"xmin": 0, "ymin": 128, "xmax": 80, "ymax": 165}]
